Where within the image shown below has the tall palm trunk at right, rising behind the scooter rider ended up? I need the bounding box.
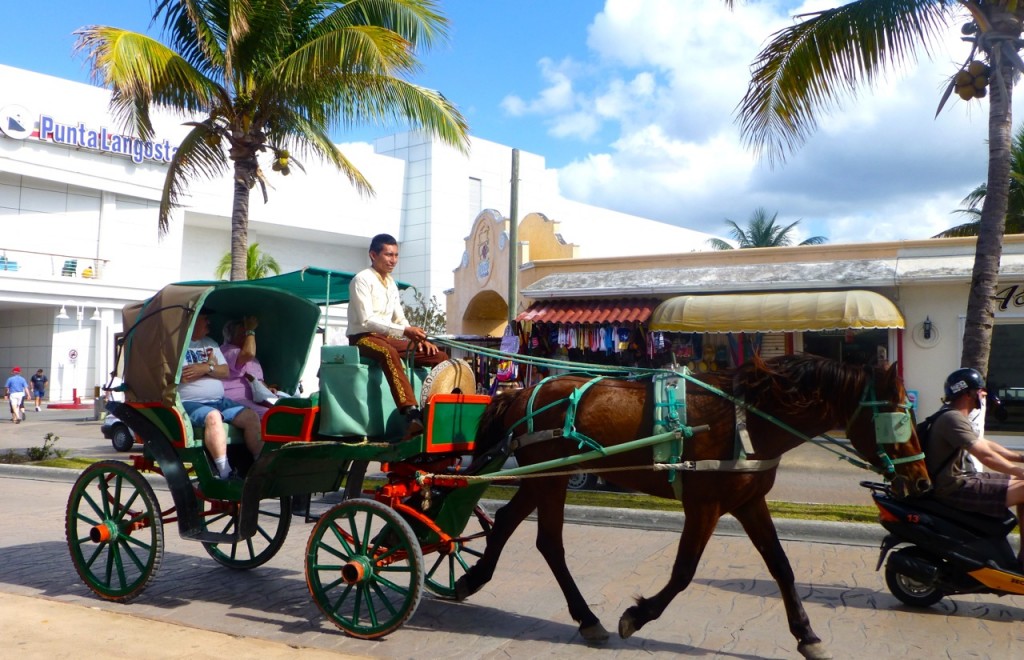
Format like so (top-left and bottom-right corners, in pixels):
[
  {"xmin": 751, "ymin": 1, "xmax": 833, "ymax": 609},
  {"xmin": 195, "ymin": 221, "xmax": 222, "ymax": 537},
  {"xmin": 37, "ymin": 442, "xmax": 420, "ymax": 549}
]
[{"xmin": 961, "ymin": 24, "xmax": 1020, "ymax": 373}]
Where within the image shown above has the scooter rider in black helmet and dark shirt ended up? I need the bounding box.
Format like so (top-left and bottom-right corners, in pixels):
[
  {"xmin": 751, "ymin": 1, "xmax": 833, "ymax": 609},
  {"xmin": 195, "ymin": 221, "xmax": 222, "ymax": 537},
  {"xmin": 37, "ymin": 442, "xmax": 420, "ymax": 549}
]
[{"xmin": 925, "ymin": 368, "xmax": 1024, "ymax": 560}]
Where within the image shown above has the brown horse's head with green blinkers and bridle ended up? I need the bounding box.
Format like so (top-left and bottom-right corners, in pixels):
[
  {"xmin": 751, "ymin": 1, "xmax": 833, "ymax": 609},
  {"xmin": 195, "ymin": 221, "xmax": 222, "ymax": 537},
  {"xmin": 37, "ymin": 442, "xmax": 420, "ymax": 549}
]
[{"xmin": 847, "ymin": 364, "xmax": 932, "ymax": 496}]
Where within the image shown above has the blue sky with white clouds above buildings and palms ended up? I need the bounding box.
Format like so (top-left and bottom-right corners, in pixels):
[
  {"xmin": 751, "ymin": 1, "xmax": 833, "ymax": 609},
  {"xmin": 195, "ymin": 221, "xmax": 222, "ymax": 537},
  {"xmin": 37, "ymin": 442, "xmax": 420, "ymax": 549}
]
[{"xmin": 0, "ymin": 0, "xmax": 1015, "ymax": 244}]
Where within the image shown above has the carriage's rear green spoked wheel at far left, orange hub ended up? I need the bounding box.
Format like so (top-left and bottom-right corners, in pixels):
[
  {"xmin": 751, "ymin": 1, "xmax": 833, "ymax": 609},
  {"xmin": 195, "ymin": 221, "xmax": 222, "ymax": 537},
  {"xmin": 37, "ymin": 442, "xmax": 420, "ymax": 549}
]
[{"xmin": 65, "ymin": 460, "xmax": 164, "ymax": 603}]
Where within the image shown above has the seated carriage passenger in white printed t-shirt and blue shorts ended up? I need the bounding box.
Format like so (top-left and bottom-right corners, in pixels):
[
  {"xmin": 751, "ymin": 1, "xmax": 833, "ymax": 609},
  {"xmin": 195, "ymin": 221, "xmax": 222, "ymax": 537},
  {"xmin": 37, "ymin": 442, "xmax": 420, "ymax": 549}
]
[{"xmin": 178, "ymin": 310, "xmax": 263, "ymax": 479}]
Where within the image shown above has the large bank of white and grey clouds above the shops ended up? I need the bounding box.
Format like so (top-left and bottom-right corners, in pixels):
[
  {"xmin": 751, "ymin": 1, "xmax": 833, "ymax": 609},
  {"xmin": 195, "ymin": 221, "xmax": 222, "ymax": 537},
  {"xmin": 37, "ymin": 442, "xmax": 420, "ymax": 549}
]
[{"xmin": 505, "ymin": 0, "xmax": 1011, "ymax": 243}]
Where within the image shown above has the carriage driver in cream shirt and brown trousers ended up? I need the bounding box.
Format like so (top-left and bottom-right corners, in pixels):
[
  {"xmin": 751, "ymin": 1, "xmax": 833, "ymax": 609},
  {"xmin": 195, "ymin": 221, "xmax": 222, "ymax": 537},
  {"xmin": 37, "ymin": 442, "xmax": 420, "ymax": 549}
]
[{"xmin": 347, "ymin": 233, "xmax": 449, "ymax": 440}]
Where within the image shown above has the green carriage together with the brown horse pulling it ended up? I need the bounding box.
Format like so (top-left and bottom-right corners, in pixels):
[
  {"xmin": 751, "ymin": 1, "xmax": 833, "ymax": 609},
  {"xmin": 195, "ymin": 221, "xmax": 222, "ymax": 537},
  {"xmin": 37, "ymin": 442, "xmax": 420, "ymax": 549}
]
[{"xmin": 67, "ymin": 268, "xmax": 928, "ymax": 657}]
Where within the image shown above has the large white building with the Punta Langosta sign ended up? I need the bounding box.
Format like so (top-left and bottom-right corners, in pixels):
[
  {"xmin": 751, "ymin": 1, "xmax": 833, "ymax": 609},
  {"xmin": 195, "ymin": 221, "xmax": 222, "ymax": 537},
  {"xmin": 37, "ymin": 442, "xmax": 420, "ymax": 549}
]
[{"xmin": 0, "ymin": 64, "xmax": 709, "ymax": 400}]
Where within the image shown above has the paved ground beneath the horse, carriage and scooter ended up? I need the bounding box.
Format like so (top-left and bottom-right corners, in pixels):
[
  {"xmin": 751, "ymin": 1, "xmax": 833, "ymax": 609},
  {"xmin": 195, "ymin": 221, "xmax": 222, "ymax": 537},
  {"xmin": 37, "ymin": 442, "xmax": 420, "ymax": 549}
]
[{"xmin": 0, "ymin": 472, "xmax": 1024, "ymax": 660}]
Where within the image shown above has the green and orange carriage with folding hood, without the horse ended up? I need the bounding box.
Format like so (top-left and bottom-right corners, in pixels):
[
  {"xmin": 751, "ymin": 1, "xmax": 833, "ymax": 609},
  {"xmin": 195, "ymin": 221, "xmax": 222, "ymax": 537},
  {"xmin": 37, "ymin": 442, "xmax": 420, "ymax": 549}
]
[{"xmin": 66, "ymin": 268, "xmax": 501, "ymax": 639}]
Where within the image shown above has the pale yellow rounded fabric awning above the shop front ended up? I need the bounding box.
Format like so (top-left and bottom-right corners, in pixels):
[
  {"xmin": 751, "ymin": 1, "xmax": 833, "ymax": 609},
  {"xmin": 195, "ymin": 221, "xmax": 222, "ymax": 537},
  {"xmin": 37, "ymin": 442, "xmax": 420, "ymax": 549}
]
[{"xmin": 649, "ymin": 291, "xmax": 904, "ymax": 333}]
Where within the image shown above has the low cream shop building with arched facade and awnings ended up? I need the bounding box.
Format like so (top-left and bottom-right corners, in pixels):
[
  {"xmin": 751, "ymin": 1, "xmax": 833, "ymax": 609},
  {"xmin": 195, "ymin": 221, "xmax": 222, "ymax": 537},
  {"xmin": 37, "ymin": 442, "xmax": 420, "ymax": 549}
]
[{"xmin": 447, "ymin": 214, "xmax": 1024, "ymax": 436}]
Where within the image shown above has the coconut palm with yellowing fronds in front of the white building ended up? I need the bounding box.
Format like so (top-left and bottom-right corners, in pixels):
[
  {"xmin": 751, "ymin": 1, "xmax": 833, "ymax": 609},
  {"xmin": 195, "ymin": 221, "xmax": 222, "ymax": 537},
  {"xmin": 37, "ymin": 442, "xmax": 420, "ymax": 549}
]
[{"xmin": 76, "ymin": 0, "xmax": 468, "ymax": 279}]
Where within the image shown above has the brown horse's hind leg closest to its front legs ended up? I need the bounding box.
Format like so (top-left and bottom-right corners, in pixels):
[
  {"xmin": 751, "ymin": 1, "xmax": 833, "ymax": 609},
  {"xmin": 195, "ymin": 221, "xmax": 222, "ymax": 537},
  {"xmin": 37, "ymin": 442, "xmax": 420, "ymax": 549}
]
[{"xmin": 530, "ymin": 478, "xmax": 608, "ymax": 644}]
